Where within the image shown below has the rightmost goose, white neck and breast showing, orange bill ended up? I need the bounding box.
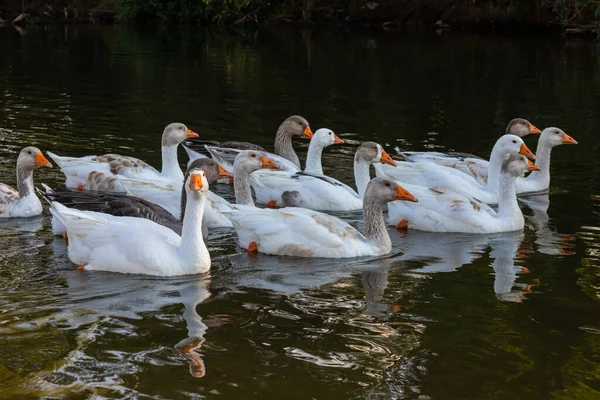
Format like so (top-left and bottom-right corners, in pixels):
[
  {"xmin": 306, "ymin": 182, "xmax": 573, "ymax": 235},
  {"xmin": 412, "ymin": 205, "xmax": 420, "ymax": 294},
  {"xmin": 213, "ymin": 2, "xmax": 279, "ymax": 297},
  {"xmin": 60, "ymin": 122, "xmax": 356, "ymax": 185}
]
[{"xmin": 517, "ymin": 127, "xmax": 577, "ymax": 194}]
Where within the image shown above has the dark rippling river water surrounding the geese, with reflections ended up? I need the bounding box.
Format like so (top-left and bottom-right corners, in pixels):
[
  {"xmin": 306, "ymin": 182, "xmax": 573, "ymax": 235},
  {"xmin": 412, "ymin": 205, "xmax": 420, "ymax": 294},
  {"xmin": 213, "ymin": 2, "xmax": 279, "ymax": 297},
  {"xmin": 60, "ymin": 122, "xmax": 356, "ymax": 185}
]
[{"xmin": 0, "ymin": 26, "xmax": 600, "ymax": 400}]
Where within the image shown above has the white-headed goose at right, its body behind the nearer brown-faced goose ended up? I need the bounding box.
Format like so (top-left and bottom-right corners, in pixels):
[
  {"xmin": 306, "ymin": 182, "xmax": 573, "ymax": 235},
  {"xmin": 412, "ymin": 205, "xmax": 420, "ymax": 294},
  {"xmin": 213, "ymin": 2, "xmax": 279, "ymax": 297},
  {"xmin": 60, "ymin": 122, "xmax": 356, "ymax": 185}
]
[{"xmin": 375, "ymin": 135, "xmax": 535, "ymax": 204}]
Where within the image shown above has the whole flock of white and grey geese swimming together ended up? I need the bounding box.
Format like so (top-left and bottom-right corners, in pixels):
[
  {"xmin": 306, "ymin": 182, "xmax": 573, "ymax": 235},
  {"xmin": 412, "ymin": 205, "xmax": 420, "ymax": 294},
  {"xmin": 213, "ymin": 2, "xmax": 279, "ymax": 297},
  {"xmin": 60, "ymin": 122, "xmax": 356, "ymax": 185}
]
[{"xmin": 0, "ymin": 115, "xmax": 577, "ymax": 276}]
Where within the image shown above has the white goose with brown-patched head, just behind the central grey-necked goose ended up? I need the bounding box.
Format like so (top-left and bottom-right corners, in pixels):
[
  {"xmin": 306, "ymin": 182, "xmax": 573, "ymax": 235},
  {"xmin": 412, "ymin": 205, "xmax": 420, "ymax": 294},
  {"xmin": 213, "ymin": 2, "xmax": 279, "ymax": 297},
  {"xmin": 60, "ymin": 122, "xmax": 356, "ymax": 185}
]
[{"xmin": 251, "ymin": 142, "xmax": 396, "ymax": 211}]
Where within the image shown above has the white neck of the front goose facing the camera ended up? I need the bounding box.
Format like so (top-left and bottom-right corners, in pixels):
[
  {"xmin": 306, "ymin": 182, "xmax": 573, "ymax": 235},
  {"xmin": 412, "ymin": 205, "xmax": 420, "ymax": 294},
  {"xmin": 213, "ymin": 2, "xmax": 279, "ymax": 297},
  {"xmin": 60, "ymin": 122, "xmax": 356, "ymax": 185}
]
[{"xmin": 178, "ymin": 192, "xmax": 210, "ymax": 272}]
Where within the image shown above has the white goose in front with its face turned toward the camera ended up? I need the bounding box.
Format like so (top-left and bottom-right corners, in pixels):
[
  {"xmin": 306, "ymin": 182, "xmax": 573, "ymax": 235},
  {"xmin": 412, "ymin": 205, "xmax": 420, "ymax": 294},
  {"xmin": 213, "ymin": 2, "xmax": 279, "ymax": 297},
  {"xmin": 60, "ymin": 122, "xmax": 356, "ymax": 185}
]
[{"xmin": 50, "ymin": 170, "xmax": 211, "ymax": 276}]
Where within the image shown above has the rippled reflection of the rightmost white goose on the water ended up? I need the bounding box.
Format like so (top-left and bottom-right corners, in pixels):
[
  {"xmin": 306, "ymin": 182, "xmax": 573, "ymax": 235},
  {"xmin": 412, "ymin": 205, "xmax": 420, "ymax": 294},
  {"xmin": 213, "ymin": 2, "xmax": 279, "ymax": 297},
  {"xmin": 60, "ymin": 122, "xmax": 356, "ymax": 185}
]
[{"xmin": 519, "ymin": 193, "xmax": 574, "ymax": 255}]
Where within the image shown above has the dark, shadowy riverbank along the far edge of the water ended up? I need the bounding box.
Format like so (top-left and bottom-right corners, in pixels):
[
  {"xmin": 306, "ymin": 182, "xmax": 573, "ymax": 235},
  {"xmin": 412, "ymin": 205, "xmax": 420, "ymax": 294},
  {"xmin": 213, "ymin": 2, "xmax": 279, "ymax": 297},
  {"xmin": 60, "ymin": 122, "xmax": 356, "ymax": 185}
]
[{"xmin": 0, "ymin": 0, "xmax": 600, "ymax": 39}]
